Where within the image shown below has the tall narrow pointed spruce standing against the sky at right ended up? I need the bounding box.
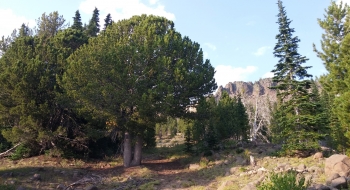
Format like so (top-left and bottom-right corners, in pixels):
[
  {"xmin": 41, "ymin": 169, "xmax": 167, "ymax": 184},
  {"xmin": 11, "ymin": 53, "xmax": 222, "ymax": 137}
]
[{"xmin": 272, "ymin": 0, "xmax": 321, "ymax": 153}]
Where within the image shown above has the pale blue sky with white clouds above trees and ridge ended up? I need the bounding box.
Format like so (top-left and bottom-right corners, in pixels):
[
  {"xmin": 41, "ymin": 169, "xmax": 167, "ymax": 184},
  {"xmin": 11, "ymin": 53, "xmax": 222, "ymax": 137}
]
[{"xmin": 0, "ymin": 0, "xmax": 344, "ymax": 86}]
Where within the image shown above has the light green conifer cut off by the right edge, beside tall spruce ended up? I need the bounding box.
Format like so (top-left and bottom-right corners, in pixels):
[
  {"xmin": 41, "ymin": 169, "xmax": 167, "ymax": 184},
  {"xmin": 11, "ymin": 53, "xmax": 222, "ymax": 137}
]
[{"xmin": 314, "ymin": 1, "xmax": 350, "ymax": 153}]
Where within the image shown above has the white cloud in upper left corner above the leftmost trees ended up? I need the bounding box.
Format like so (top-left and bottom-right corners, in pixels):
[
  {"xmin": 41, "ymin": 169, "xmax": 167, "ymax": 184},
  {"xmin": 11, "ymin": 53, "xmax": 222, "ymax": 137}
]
[{"xmin": 0, "ymin": 9, "xmax": 35, "ymax": 37}]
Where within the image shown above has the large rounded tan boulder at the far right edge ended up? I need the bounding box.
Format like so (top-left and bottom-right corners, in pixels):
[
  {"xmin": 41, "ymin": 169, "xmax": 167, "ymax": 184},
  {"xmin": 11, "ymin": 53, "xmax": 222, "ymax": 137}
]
[{"xmin": 325, "ymin": 154, "xmax": 350, "ymax": 178}]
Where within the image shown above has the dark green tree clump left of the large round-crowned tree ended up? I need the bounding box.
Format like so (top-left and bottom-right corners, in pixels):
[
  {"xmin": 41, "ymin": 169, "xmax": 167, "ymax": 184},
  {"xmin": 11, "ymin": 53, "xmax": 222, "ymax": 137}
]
[{"xmin": 0, "ymin": 12, "xmax": 115, "ymax": 157}]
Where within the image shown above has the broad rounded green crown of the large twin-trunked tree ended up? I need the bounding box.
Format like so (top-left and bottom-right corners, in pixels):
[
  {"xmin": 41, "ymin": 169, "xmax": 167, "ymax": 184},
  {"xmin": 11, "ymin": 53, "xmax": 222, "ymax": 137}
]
[{"xmin": 63, "ymin": 15, "xmax": 216, "ymax": 165}]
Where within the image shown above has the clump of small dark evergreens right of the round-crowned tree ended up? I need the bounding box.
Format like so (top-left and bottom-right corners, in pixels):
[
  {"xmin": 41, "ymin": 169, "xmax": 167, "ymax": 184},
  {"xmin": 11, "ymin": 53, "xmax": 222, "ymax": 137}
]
[{"xmin": 193, "ymin": 92, "xmax": 249, "ymax": 151}]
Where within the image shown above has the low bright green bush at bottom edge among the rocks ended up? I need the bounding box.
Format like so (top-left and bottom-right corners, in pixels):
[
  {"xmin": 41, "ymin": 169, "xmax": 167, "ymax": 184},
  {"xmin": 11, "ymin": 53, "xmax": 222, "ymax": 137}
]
[{"xmin": 257, "ymin": 171, "xmax": 310, "ymax": 190}]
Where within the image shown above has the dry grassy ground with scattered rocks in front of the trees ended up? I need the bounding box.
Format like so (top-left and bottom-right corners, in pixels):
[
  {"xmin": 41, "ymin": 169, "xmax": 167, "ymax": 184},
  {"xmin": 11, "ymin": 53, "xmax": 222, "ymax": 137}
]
[{"xmin": 0, "ymin": 137, "xmax": 325, "ymax": 190}]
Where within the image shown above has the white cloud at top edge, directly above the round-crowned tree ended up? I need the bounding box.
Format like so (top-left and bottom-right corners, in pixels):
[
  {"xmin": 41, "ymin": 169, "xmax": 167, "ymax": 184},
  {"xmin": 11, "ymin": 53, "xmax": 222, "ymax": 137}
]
[{"xmin": 79, "ymin": 0, "xmax": 175, "ymax": 23}]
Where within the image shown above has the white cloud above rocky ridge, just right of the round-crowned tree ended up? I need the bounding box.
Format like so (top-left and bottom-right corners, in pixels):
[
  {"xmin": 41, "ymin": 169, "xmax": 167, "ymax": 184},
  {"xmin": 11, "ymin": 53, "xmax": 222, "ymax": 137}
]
[{"xmin": 214, "ymin": 65, "xmax": 258, "ymax": 86}]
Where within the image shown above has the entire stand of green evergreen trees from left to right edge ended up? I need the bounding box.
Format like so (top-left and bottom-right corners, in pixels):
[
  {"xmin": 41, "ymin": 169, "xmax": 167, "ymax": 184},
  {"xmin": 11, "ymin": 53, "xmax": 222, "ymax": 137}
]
[{"xmin": 0, "ymin": 0, "xmax": 350, "ymax": 167}]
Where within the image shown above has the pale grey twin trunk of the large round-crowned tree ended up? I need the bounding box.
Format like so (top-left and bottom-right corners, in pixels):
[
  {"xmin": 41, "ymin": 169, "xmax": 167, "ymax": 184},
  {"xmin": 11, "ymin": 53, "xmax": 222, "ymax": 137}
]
[{"xmin": 123, "ymin": 132, "xmax": 143, "ymax": 168}]
